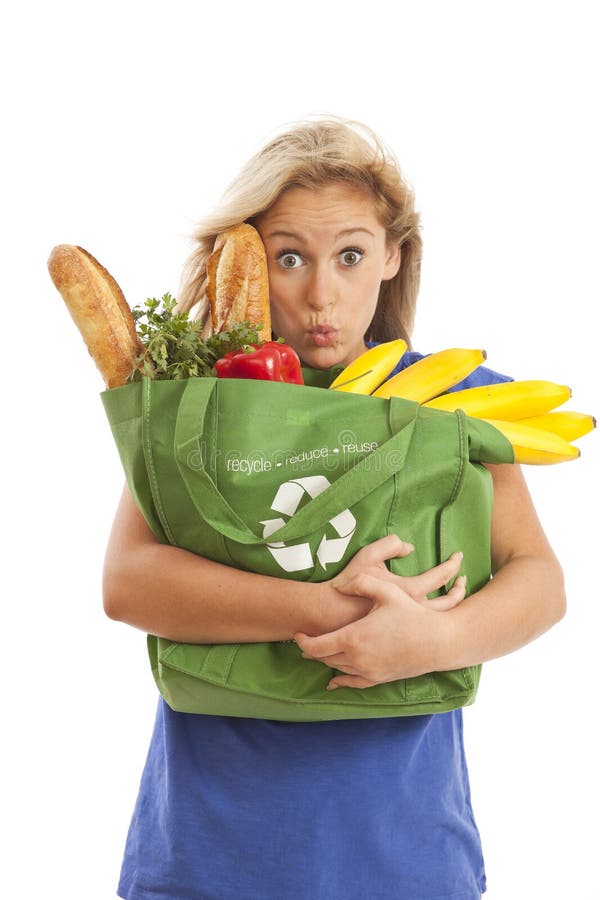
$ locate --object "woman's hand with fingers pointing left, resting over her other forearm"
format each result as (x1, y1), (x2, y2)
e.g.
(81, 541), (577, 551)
(294, 573), (464, 690)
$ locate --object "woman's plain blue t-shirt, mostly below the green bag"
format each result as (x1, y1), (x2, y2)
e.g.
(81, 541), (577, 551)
(118, 353), (509, 900)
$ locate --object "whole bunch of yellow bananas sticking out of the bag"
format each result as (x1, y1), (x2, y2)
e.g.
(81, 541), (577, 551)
(331, 340), (596, 465)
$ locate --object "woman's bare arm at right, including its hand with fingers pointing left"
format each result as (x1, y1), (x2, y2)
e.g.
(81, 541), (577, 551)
(296, 465), (565, 687)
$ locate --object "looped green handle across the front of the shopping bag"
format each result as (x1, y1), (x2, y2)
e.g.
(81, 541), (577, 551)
(164, 378), (418, 545)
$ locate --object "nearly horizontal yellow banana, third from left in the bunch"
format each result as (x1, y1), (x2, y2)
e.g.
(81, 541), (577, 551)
(425, 381), (571, 421)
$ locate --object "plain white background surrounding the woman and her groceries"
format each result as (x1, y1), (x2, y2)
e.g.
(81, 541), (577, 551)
(0, 0), (600, 900)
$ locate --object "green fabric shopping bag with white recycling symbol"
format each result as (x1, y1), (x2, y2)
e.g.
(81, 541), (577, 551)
(102, 370), (514, 721)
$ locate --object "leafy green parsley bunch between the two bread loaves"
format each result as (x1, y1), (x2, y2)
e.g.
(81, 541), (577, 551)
(130, 294), (260, 381)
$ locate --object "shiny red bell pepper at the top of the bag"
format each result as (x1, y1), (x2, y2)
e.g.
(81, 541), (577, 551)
(215, 341), (304, 384)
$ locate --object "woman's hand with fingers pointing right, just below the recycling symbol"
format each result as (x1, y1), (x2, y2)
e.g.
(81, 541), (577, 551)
(321, 534), (466, 631)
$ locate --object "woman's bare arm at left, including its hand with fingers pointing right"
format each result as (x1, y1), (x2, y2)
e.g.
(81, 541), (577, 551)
(103, 487), (464, 644)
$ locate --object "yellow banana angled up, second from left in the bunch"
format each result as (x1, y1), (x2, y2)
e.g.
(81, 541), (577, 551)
(373, 348), (486, 403)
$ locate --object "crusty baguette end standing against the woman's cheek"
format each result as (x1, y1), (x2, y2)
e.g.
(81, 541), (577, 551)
(206, 223), (271, 341)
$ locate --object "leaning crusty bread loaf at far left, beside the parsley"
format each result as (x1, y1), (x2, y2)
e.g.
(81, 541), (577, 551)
(48, 244), (144, 388)
